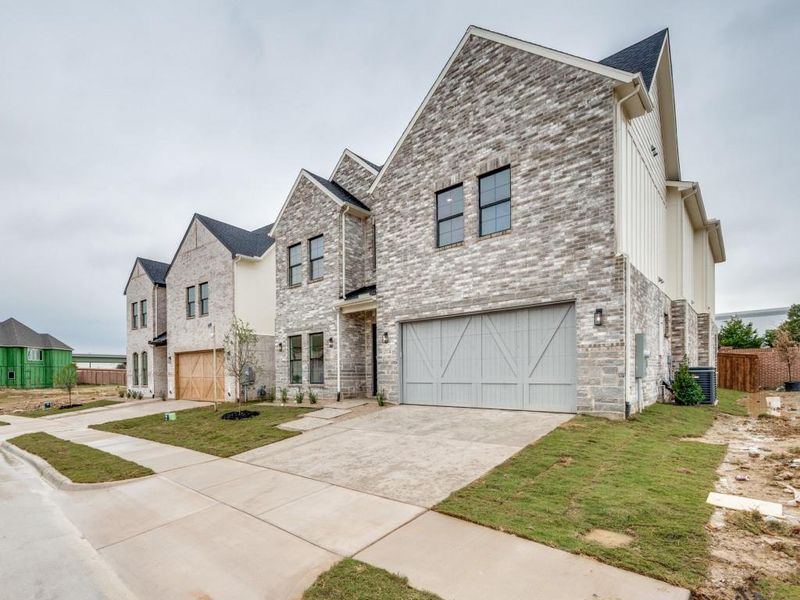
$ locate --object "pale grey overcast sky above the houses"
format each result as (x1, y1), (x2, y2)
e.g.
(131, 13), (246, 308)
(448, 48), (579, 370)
(0, 0), (800, 353)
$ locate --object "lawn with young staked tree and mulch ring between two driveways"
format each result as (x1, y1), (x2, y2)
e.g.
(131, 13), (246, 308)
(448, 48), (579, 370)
(92, 405), (312, 457)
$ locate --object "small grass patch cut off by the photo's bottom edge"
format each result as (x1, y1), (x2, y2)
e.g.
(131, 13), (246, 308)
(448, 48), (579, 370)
(303, 558), (441, 600)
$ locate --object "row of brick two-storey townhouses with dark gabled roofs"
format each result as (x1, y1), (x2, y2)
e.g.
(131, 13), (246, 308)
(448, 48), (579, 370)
(127, 27), (725, 417)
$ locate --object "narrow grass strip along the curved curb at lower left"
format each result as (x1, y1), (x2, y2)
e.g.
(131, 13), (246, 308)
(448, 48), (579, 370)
(8, 432), (153, 483)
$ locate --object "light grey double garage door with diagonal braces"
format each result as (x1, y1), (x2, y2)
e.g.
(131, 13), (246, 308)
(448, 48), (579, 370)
(402, 304), (577, 412)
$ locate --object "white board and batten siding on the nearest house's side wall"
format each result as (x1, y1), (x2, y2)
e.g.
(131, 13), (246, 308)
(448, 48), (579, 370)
(616, 78), (667, 285)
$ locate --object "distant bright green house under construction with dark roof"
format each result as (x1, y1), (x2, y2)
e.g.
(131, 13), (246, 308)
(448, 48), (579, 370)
(0, 319), (72, 389)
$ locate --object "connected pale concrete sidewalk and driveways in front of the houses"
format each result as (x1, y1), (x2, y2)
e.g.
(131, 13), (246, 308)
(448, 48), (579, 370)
(0, 402), (688, 600)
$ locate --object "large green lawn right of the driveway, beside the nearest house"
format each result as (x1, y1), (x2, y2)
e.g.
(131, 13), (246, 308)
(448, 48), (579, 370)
(435, 404), (725, 588)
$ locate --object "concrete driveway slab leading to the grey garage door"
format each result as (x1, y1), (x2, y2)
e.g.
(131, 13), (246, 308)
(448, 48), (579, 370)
(234, 405), (571, 508)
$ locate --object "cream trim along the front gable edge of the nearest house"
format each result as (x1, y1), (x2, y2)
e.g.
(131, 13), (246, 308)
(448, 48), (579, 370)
(368, 25), (653, 194)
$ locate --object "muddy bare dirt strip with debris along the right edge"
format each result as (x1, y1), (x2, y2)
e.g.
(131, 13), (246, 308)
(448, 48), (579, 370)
(694, 392), (800, 600)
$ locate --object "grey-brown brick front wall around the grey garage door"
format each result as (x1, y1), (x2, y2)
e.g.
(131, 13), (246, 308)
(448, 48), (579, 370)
(372, 38), (625, 415)
